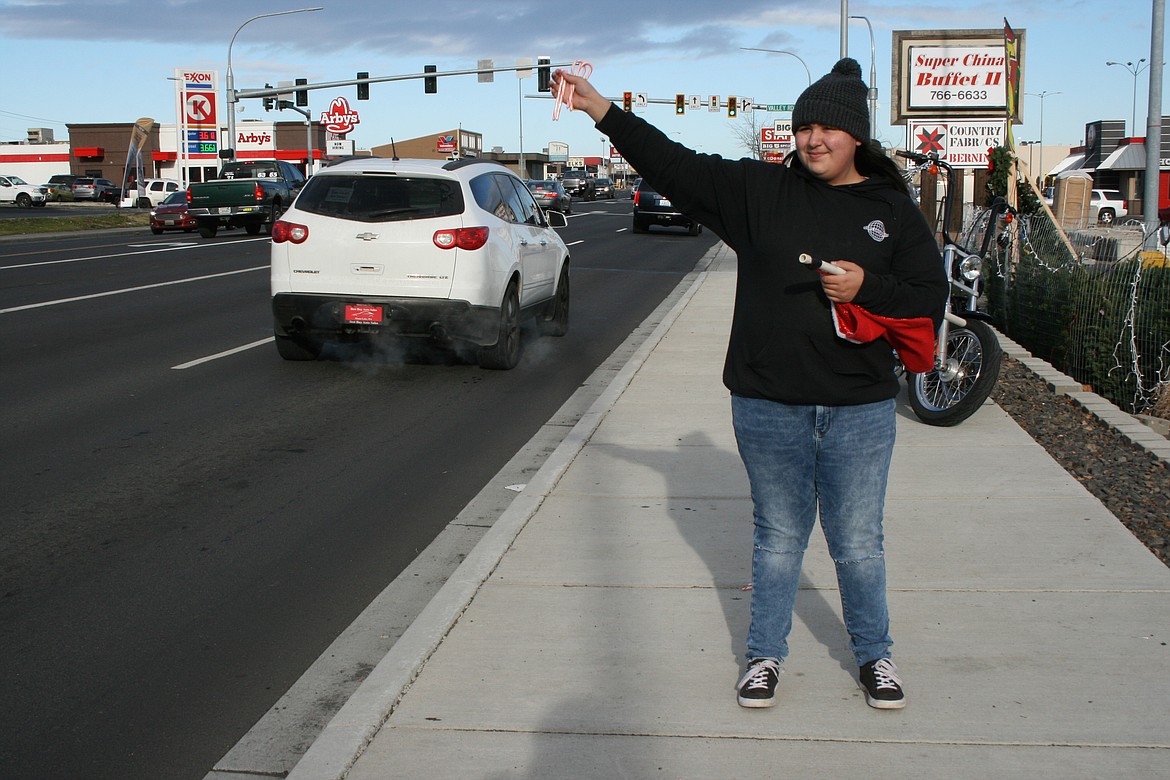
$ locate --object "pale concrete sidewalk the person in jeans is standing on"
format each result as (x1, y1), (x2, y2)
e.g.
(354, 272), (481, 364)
(289, 248), (1170, 780)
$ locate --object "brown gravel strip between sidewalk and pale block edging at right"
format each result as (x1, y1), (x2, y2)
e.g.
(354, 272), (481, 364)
(991, 354), (1170, 566)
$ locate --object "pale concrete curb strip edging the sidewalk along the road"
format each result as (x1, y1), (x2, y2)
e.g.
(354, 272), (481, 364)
(279, 242), (727, 780)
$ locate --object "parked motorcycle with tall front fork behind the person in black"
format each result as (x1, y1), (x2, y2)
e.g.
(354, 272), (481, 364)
(896, 151), (1014, 427)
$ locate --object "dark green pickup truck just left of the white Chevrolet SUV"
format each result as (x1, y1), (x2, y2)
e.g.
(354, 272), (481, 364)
(187, 160), (304, 239)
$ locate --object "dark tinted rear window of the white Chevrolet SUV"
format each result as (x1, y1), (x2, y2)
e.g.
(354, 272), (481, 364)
(296, 174), (463, 222)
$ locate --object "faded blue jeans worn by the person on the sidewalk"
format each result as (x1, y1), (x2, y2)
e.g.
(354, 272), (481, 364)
(731, 395), (895, 665)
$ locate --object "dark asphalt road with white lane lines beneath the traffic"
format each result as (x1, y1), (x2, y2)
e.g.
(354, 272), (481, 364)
(0, 201), (714, 780)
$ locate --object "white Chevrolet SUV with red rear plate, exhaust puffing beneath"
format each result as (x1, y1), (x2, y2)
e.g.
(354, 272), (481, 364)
(271, 158), (569, 368)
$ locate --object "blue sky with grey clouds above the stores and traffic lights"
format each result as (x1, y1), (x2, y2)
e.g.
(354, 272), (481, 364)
(0, 0), (1170, 157)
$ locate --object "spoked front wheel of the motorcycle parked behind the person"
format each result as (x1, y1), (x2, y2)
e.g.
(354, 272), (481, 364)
(906, 319), (1004, 427)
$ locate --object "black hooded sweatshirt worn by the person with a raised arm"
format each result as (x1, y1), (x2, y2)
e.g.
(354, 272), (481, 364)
(597, 106), (949, 406)
